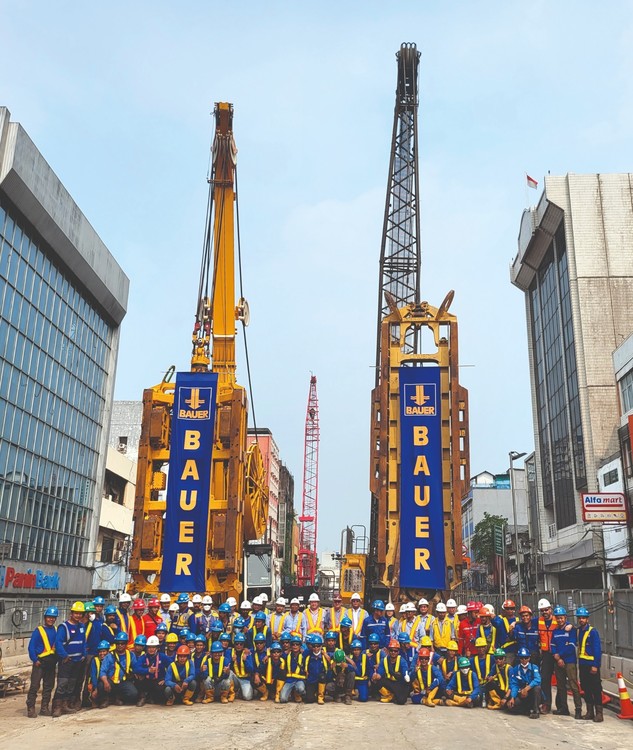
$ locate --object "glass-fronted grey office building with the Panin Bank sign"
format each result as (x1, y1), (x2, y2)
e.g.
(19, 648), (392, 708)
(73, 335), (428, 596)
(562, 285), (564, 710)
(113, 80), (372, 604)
(0, 108), (129, 604)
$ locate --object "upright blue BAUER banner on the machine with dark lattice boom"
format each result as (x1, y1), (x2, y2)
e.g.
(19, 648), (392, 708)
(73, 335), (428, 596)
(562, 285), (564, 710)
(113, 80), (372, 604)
(398, 367), (446, 589)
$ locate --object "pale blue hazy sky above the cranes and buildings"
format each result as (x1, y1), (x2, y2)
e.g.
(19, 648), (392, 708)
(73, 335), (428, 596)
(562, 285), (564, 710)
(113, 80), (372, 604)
(0, 0), (633, 549)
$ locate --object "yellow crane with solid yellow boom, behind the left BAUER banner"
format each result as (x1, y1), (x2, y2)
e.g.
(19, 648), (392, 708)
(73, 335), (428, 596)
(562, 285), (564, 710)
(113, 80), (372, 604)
(130, 102), (268, 596)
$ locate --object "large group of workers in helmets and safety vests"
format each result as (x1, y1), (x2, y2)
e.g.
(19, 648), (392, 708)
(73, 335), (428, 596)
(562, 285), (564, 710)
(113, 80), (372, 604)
(27, 593), (603, 722)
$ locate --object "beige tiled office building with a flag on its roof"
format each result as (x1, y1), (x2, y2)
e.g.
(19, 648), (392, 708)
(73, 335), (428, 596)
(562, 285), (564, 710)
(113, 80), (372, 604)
(510, 174), (633, 588)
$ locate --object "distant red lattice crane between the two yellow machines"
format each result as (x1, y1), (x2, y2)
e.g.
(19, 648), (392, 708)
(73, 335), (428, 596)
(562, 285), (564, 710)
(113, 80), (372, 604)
(297, 375), (319, 586)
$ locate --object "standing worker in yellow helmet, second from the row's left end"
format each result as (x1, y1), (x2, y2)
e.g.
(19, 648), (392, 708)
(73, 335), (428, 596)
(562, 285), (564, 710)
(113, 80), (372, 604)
(51, 602), (87, 718)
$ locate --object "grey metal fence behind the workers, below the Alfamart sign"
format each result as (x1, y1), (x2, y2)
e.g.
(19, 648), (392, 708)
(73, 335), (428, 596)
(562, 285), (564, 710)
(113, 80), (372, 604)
(453, 589), (633, 659)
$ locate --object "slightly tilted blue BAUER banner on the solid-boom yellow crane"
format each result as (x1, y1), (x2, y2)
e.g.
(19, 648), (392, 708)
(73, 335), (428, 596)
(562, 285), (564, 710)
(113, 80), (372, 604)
(160, 372), (218, 593)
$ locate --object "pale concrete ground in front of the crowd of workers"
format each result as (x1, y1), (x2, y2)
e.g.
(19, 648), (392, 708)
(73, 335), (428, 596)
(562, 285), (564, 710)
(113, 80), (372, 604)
(0, 695), (633, 750)
